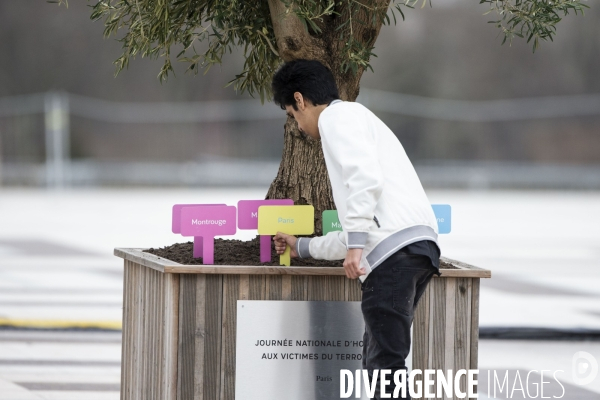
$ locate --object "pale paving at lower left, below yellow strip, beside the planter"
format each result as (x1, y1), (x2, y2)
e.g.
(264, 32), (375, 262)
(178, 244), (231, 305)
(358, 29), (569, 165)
(0, 330), (121, 400)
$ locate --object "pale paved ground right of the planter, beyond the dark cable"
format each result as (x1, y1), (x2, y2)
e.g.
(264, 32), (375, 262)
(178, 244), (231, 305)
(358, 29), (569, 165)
(430, 191), (600, 329)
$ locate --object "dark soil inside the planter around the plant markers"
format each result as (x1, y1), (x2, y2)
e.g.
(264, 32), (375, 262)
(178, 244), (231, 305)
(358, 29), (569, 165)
(145, 236), (455, 269)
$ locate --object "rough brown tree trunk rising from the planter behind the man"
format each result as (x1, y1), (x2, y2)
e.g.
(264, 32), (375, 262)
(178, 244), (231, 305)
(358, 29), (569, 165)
(266, 0), (389, 235)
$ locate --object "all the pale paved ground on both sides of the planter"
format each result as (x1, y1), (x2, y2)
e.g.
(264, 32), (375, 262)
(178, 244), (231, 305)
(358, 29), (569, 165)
(0, 188), (600, 400)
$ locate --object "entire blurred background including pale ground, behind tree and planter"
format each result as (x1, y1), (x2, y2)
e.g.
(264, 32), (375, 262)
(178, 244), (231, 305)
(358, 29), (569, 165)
(0, 0), (600, 400)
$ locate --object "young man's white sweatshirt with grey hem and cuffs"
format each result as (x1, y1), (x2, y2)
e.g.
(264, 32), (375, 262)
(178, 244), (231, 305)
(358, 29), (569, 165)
(296, 100), (438, 280)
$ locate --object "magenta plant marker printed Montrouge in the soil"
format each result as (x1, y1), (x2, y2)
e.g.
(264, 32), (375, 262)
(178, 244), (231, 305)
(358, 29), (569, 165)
(181, 205), (237, 265)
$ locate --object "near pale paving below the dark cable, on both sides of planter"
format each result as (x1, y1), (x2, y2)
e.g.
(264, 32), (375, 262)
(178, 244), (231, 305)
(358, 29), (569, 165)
(0, 330), (600, 400)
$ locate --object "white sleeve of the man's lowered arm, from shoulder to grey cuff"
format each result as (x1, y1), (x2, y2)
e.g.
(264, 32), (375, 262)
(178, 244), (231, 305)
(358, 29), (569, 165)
(319, 104), (384, 249)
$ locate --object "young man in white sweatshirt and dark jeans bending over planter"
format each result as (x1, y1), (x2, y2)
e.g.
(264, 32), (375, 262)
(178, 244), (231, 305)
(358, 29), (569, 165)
(273, 60), (440, 399)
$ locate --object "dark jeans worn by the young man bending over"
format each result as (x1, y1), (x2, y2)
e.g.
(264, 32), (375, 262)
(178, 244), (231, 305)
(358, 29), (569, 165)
(361, 250), (437, 399)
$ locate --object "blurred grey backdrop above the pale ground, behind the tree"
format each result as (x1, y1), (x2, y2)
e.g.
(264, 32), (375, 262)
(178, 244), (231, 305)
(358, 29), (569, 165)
(0, 0), (600, 189)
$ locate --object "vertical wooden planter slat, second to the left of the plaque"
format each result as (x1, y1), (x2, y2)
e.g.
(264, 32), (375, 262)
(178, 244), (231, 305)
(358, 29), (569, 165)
(204, 275), (223, 400)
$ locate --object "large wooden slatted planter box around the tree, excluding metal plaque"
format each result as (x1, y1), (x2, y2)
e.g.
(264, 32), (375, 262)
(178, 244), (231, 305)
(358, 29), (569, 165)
(114, 248), (491, 400)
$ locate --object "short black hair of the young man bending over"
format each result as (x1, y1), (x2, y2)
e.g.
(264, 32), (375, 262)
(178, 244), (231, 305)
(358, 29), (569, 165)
(271, 60), (340, 110)
